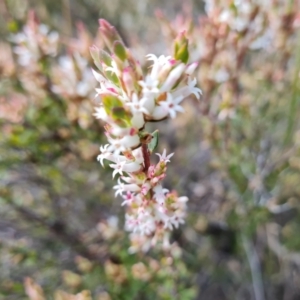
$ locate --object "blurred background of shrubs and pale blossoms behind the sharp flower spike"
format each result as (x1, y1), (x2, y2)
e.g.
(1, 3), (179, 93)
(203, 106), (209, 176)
(0, 0), (300, 300)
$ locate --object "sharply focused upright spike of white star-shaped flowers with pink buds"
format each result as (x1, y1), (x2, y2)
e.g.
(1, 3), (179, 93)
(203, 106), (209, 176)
(91, 20), (201, 250)
